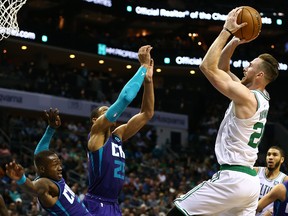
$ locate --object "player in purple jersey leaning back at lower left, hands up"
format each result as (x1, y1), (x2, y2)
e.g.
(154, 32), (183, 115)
(6, 108), (91, 216)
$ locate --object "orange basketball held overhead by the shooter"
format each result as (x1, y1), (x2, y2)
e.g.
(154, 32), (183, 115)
(234, 6), (262, 40)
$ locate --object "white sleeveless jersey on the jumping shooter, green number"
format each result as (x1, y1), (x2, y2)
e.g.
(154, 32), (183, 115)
(215, 90), (270, 168)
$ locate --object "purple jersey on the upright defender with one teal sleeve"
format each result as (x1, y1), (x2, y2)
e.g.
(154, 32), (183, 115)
(84, 135), (125, 202)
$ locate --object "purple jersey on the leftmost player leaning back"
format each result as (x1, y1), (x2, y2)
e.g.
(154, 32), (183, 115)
(40, 178), (91, 216)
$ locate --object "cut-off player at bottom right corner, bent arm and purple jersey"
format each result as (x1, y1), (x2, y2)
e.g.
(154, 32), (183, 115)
(257, 181), (288, 216)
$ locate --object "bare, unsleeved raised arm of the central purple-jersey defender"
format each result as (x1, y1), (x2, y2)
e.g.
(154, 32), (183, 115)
(114, 59), (155, 141)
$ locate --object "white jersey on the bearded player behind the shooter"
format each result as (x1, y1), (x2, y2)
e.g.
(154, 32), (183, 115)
(256, 167), (286, 216)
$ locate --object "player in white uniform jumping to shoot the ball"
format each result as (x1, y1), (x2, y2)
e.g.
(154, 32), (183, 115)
(168, 8), (278, 216)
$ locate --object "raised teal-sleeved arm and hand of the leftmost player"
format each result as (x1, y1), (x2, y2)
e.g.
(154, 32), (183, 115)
(34, 108), (61, 155)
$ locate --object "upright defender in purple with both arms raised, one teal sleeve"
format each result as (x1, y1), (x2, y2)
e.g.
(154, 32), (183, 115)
(84, 45), (154, 216)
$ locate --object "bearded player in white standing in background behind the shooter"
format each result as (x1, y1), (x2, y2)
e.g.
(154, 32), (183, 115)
(254, 146), (288, 216)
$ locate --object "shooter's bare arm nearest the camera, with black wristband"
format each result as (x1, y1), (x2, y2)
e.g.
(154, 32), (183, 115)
(200, 8), (257, 112)
